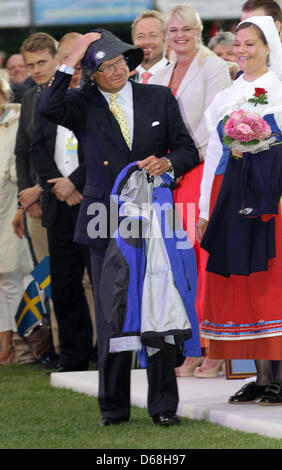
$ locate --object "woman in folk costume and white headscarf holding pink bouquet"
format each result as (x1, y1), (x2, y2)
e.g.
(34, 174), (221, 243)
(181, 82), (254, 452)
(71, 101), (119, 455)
(197, 16), (282, 405)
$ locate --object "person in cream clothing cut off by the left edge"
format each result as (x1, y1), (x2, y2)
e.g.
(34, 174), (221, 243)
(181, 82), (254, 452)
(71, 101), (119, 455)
(0, 76), (32, 364)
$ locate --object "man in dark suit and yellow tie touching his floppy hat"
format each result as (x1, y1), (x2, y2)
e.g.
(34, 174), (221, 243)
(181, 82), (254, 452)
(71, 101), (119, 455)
(39, 30), (199, 426)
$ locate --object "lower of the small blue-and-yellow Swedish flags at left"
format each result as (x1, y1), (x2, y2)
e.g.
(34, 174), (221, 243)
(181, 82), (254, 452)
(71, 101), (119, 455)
(15, 281), (44, 336)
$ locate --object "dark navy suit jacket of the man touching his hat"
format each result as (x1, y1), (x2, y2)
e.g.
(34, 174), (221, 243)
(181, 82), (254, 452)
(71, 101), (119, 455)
(38, 71), (199, 246)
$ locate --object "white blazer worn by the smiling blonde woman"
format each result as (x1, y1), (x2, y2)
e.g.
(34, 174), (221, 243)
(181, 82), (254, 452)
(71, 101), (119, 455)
(148, 52), (231, 160)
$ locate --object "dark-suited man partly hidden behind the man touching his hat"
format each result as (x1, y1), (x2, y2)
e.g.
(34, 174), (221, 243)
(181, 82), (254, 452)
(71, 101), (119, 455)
(30, 32), (93, 372)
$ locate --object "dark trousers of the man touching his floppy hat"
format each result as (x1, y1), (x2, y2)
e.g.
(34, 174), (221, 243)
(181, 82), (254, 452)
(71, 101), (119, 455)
(90, 242), (178, 418)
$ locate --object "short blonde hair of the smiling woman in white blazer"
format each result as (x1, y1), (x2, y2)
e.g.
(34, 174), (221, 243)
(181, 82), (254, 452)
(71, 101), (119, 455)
(164, 5), (216, 64)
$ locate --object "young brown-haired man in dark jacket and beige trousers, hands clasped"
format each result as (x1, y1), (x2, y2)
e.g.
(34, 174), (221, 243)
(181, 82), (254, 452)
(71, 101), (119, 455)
(12, 32), (58, 367)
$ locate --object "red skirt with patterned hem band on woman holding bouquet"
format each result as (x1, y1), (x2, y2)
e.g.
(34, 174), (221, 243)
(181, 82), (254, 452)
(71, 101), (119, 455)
(202, 175), (282, 360)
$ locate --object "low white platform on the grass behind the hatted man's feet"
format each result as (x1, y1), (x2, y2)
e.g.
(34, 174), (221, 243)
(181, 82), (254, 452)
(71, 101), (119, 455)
(51, 369), (282, 439)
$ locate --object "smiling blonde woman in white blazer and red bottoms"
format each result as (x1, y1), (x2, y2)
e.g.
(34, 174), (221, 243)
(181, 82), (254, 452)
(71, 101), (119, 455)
(149, 5), (231, 377)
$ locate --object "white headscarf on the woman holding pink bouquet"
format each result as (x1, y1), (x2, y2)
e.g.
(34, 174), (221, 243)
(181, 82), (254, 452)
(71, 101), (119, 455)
(238, 16), (282, 80)
